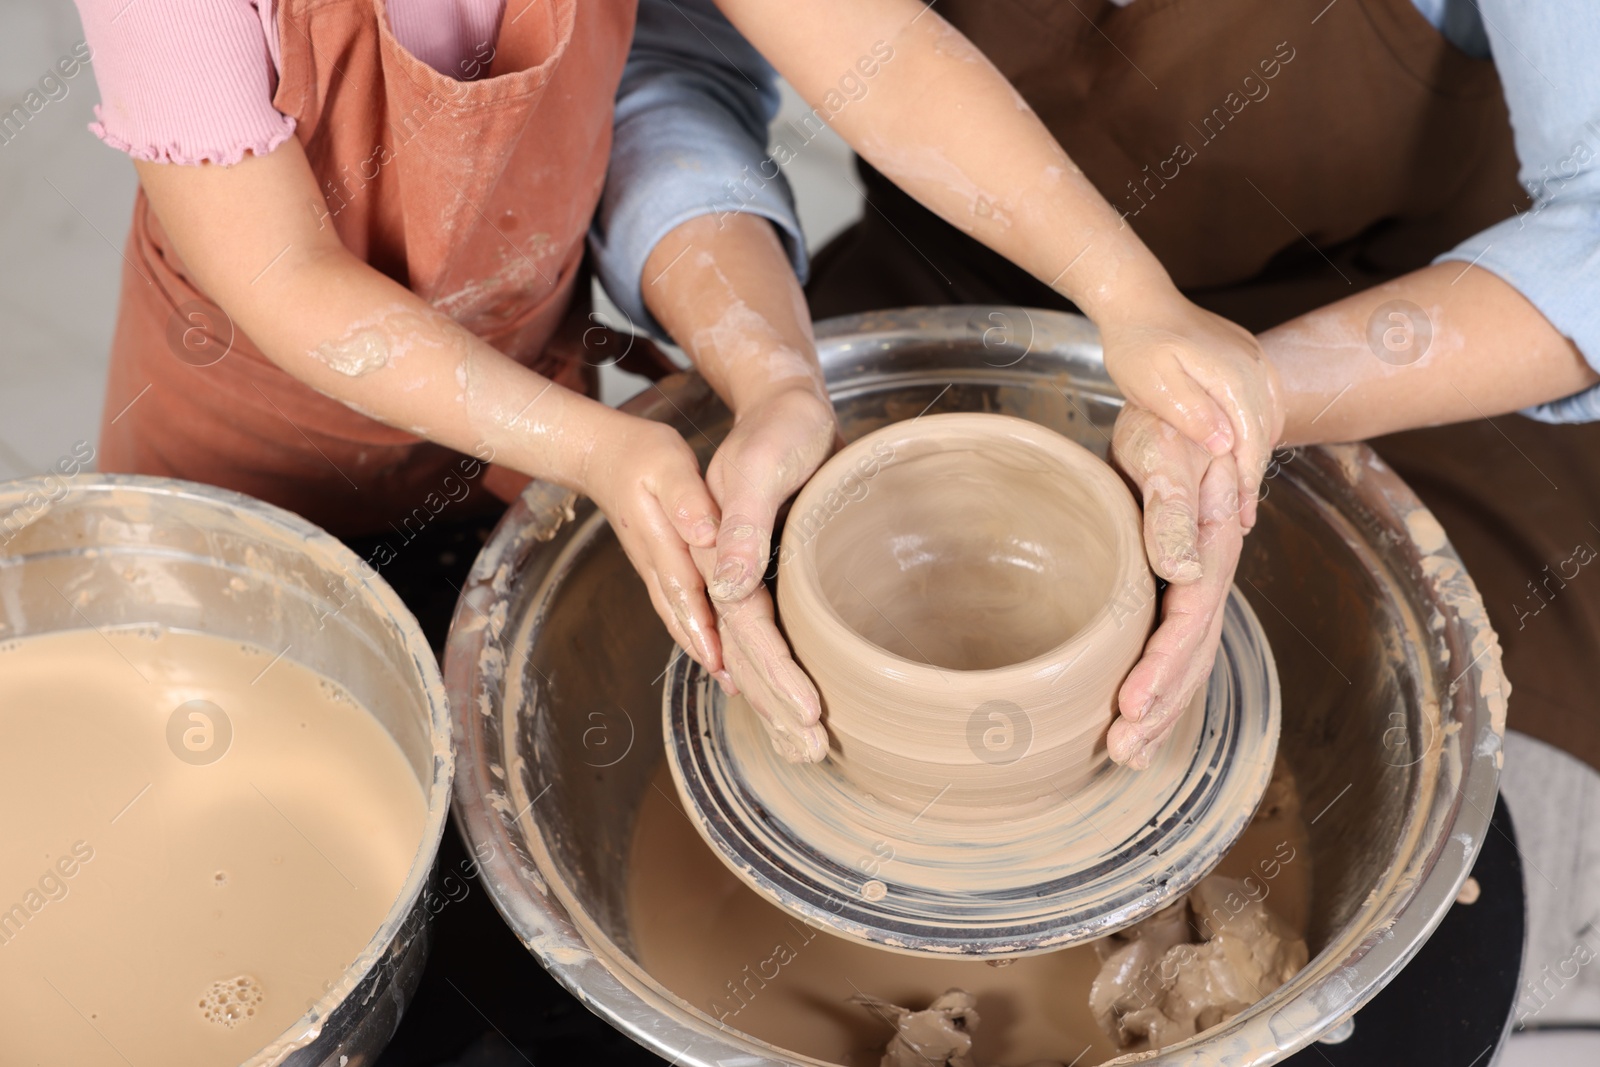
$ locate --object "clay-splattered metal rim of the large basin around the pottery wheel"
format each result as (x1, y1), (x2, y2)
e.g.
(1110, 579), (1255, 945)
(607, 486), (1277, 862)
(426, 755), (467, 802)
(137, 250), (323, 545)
(445, 307), (1507, 1067)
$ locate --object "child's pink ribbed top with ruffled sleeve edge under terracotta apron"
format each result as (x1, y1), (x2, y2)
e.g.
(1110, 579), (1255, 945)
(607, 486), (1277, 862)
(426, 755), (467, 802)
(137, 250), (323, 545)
(77, 0), (506, 163)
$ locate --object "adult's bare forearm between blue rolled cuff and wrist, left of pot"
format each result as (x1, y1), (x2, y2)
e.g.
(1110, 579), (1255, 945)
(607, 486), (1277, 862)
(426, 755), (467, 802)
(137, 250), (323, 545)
(643, 214), (826, 413)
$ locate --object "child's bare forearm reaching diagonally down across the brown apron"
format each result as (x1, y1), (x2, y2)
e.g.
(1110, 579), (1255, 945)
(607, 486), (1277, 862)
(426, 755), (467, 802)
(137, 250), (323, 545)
(718, 0), (1176, 322)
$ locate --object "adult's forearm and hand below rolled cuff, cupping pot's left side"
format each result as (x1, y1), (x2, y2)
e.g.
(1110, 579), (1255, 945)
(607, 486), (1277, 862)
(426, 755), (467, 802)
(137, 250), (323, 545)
(643, 213), (838, 761)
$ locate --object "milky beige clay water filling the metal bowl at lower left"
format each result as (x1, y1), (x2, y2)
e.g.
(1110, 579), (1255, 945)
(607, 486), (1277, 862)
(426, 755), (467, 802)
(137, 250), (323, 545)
(0, 629), (427, 1067)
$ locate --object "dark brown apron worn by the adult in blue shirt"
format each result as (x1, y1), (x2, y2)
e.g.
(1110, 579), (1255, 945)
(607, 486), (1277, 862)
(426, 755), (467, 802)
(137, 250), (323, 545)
(808, 0), (1600, 768)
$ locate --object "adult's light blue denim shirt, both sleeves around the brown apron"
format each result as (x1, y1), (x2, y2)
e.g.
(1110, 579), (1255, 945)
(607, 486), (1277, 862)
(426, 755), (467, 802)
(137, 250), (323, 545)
(590, 0), (1600, 422)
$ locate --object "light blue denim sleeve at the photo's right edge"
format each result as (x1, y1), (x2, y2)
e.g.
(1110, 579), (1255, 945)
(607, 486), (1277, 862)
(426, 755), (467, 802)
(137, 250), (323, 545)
(1437, 0), (1600, 422)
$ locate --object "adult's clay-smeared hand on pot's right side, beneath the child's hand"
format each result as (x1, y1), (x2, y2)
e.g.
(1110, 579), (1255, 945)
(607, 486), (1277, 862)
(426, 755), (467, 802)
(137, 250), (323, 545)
(1106, 403), (1243, 769)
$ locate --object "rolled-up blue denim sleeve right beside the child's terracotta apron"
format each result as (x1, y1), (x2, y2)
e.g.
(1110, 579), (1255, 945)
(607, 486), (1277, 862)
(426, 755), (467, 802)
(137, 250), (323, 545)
(589, 0), (806, 338)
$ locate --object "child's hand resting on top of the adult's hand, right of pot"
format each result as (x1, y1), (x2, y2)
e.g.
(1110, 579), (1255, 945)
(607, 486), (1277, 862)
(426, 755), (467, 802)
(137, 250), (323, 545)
(1098, 291), (1283, 534)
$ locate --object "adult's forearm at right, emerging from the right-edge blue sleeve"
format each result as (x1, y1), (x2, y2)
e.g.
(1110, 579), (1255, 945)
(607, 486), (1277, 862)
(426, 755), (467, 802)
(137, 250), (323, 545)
(1261, 262), (1600, 445)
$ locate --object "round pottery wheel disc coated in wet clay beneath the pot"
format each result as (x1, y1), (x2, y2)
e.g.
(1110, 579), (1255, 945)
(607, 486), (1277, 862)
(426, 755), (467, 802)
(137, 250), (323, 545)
(662, 589), (1280, 957)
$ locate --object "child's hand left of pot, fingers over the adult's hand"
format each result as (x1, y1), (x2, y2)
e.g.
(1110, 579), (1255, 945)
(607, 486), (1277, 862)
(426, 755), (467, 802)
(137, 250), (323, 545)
(579, 408), (723, 675)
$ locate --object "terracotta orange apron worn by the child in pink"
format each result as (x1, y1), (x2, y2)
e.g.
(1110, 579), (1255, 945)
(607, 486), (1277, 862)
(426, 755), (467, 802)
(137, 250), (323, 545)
(99, 0), (635, 534)
